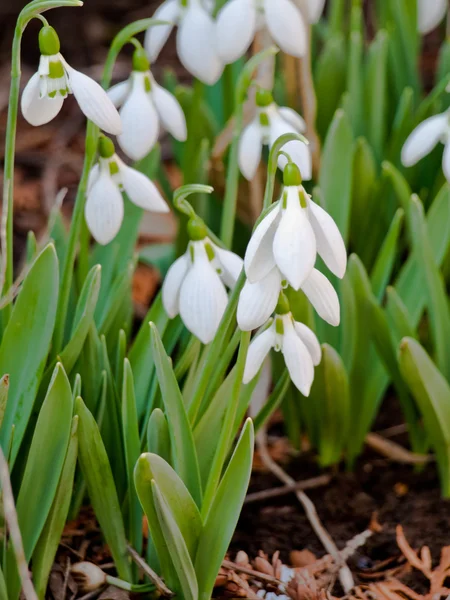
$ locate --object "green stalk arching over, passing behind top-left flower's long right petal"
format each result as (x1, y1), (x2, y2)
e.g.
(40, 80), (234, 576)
(52, 19), (166, 358)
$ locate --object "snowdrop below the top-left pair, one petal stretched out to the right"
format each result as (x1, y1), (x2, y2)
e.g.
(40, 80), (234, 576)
(84, 136), (169, 245)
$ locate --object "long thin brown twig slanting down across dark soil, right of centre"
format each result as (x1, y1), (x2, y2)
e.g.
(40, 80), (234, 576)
(256, 428), (354, 593)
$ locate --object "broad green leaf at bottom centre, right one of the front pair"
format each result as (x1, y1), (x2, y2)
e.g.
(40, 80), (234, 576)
(194, 419), (254, 600)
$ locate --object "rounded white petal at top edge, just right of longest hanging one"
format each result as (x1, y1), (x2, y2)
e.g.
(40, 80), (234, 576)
(216, 0), (256, 64)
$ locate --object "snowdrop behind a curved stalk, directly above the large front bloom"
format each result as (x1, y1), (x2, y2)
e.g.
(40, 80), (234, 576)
(238, 89), (312, 181)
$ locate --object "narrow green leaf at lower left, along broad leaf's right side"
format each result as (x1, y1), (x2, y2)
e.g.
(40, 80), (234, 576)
(33, 416), (78, 600)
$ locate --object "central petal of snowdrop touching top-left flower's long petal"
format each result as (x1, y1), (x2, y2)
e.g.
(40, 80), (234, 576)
(117, 73), (159, 160)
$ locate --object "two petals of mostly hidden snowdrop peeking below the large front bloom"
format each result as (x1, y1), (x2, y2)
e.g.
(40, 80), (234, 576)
(237, 267), (341, 331)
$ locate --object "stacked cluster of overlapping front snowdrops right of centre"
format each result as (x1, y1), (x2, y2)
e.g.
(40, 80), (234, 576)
(237, 163), (347, 396)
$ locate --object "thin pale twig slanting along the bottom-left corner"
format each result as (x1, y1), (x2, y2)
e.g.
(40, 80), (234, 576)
(0, 448), (38, 600)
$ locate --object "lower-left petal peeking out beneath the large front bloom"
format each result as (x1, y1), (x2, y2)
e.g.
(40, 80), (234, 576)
(237, 267), (281, 331)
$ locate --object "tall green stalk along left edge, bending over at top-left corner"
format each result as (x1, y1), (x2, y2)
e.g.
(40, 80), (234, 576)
(0, 0), (82, 326)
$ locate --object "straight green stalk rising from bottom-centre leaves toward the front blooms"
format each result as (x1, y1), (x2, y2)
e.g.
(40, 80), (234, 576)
(201, 332), (251, 522)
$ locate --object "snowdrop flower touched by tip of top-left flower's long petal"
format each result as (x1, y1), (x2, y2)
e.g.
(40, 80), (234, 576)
(108, 48), (187, 160)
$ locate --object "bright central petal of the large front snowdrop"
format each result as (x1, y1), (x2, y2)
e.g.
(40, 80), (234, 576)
(273, 187), (316, 290)
